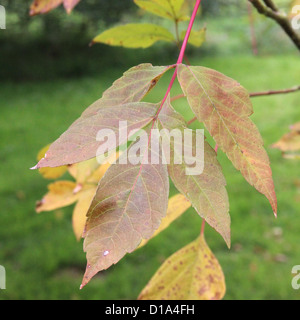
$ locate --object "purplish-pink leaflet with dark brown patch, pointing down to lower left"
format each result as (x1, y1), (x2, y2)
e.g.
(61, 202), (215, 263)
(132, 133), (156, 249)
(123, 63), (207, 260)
(83, 125), (169, 285)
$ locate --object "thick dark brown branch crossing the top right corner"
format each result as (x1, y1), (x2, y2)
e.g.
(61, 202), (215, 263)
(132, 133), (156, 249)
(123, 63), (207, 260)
(248, 0), (300, 51)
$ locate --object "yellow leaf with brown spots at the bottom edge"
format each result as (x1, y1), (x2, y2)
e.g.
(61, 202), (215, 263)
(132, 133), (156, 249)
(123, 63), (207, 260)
(139, 236), (226, 300)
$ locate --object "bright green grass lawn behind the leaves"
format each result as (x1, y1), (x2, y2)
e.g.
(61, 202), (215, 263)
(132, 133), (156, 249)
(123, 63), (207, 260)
(0, 55), (300, 299)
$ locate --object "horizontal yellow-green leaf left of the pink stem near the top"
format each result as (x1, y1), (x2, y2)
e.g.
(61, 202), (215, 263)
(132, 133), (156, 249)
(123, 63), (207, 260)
(92, 23), (174, 48)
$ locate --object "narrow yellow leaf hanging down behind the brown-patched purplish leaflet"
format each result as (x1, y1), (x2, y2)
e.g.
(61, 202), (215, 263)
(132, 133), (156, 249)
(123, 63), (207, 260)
(72, 186), (97, 241)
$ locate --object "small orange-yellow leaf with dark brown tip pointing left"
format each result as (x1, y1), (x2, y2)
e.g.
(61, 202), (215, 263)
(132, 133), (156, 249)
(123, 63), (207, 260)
(36, 181), (80, 212)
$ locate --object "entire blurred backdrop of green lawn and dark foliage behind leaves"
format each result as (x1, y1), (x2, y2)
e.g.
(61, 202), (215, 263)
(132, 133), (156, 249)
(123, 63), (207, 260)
(0, 0), (300, 300)
